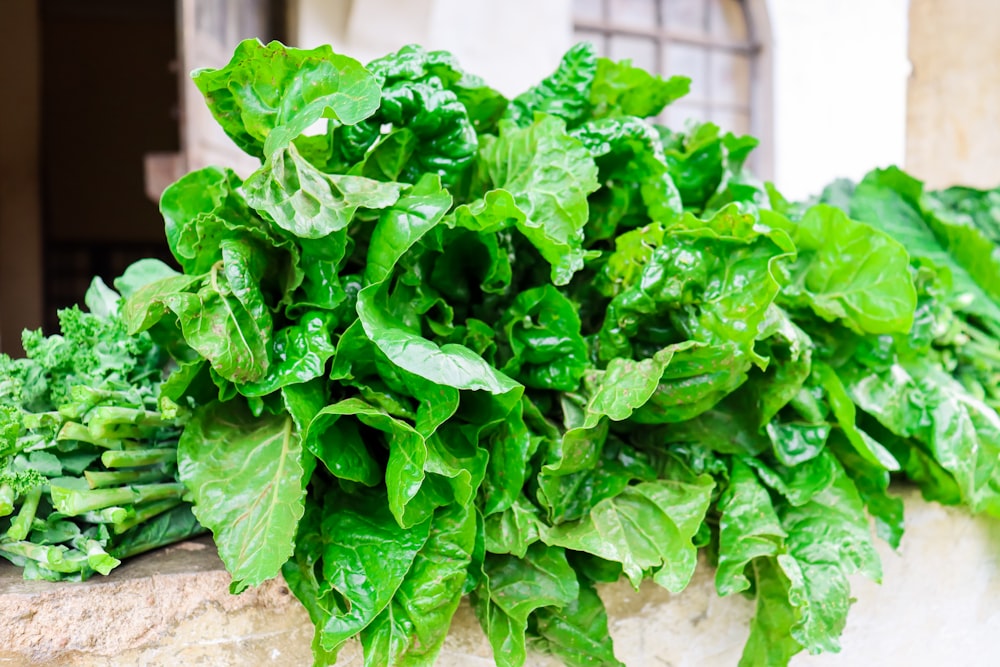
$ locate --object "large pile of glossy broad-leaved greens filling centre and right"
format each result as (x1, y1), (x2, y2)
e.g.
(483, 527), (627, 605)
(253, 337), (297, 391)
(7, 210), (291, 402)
(5, 41), (1000, 665)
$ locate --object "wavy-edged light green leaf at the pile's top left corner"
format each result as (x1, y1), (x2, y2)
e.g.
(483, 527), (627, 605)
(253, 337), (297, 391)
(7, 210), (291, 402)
(192, 39), (379, 158)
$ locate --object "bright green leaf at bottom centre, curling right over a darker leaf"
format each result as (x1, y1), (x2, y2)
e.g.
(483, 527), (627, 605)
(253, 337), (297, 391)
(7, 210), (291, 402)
(472, 543), (580, 667)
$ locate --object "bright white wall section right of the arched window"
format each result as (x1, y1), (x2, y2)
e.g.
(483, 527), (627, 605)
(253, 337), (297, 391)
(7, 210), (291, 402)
(767, 0), (910, 198)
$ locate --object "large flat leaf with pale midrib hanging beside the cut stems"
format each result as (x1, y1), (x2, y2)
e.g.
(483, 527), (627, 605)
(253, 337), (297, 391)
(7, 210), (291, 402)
(177, 401), (304, 593)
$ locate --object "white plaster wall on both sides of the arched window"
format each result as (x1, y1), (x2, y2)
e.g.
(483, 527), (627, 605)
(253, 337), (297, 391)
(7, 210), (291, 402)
(292, 0), (910, 198)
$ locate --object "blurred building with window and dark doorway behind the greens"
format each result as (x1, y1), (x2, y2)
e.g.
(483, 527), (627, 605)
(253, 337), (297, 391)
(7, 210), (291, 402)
(0, 0), (988, 355)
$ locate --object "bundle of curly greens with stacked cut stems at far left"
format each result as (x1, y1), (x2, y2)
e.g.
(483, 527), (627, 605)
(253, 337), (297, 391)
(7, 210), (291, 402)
(0, 276), (204, 581)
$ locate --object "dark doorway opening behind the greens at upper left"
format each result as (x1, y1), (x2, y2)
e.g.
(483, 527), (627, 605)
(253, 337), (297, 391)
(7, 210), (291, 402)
(40, 0), (180, 333)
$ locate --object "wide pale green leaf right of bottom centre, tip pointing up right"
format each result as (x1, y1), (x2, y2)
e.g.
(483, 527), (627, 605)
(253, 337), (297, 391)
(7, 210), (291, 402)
(544, 475), (715, 593)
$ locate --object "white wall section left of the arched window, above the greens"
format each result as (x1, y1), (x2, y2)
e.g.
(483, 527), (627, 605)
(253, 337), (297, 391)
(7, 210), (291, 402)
(291, 0), (572, 96)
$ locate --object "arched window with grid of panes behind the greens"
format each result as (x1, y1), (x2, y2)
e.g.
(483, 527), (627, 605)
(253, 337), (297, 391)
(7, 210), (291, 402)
(573, 0), (771, 176)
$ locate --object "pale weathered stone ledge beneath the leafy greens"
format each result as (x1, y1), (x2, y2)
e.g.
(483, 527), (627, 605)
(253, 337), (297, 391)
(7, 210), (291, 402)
(0, 489), (1000, 667)
